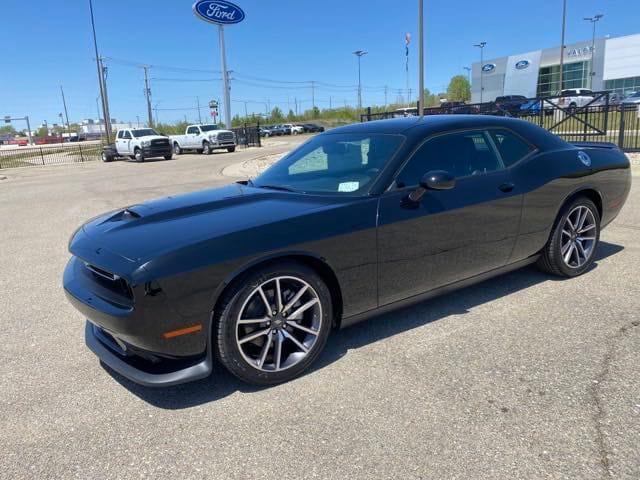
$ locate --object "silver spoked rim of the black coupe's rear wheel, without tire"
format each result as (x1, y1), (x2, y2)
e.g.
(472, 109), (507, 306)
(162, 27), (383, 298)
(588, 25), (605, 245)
(560, 205), (596, 268)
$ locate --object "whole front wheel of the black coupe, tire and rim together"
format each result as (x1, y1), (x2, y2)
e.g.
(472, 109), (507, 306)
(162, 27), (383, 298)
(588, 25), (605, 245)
(213, 262), (333, 385)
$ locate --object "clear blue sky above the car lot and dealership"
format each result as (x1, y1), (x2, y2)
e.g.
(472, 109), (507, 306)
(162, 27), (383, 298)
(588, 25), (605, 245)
(0, 0), (640, 125)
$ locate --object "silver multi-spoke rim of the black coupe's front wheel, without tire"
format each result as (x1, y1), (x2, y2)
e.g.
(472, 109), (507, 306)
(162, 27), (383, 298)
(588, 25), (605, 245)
(236, 276), (322, 372)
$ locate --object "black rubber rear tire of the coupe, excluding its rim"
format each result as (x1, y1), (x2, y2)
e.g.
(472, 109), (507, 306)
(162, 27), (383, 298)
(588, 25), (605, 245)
(537, 197), (600, 277)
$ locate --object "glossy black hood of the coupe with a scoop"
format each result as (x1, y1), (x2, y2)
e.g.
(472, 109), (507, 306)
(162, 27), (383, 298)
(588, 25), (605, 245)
(75, 184), (336, 265)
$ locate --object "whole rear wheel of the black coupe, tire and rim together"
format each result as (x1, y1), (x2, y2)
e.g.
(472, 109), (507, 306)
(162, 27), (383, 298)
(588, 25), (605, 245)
(538, 197), (600, 277)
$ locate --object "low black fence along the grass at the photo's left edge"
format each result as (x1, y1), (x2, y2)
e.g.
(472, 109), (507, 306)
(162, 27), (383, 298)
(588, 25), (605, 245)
(0, 142), (102, 169)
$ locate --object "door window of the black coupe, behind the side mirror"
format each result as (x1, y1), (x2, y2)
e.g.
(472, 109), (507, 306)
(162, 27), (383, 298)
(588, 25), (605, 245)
(396, 131), (503, 187)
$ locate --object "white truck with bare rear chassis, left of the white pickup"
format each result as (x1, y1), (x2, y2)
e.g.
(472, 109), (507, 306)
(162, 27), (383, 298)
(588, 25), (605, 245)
(115, 128), (173, 162)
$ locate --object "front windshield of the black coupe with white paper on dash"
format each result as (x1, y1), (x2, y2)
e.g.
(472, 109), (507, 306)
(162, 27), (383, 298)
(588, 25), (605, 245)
(253, 133), (404, 194)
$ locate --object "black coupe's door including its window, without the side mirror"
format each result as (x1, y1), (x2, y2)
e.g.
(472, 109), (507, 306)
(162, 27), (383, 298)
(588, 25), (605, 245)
(378, 130), (522, 305)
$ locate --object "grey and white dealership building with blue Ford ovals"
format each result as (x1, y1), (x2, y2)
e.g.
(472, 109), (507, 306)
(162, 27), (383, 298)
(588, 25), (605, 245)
(471, 34), (640, 103)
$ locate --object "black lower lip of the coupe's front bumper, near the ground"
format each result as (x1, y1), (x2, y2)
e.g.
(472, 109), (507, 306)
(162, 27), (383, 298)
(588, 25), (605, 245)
(84, 320), (212, 387)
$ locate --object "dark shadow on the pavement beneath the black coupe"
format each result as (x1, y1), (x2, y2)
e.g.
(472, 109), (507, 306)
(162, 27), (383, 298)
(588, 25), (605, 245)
(103, 242), (624, 410)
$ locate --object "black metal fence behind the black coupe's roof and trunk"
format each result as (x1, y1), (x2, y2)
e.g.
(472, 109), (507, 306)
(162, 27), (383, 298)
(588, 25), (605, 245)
(360, 92), (640, 152)
